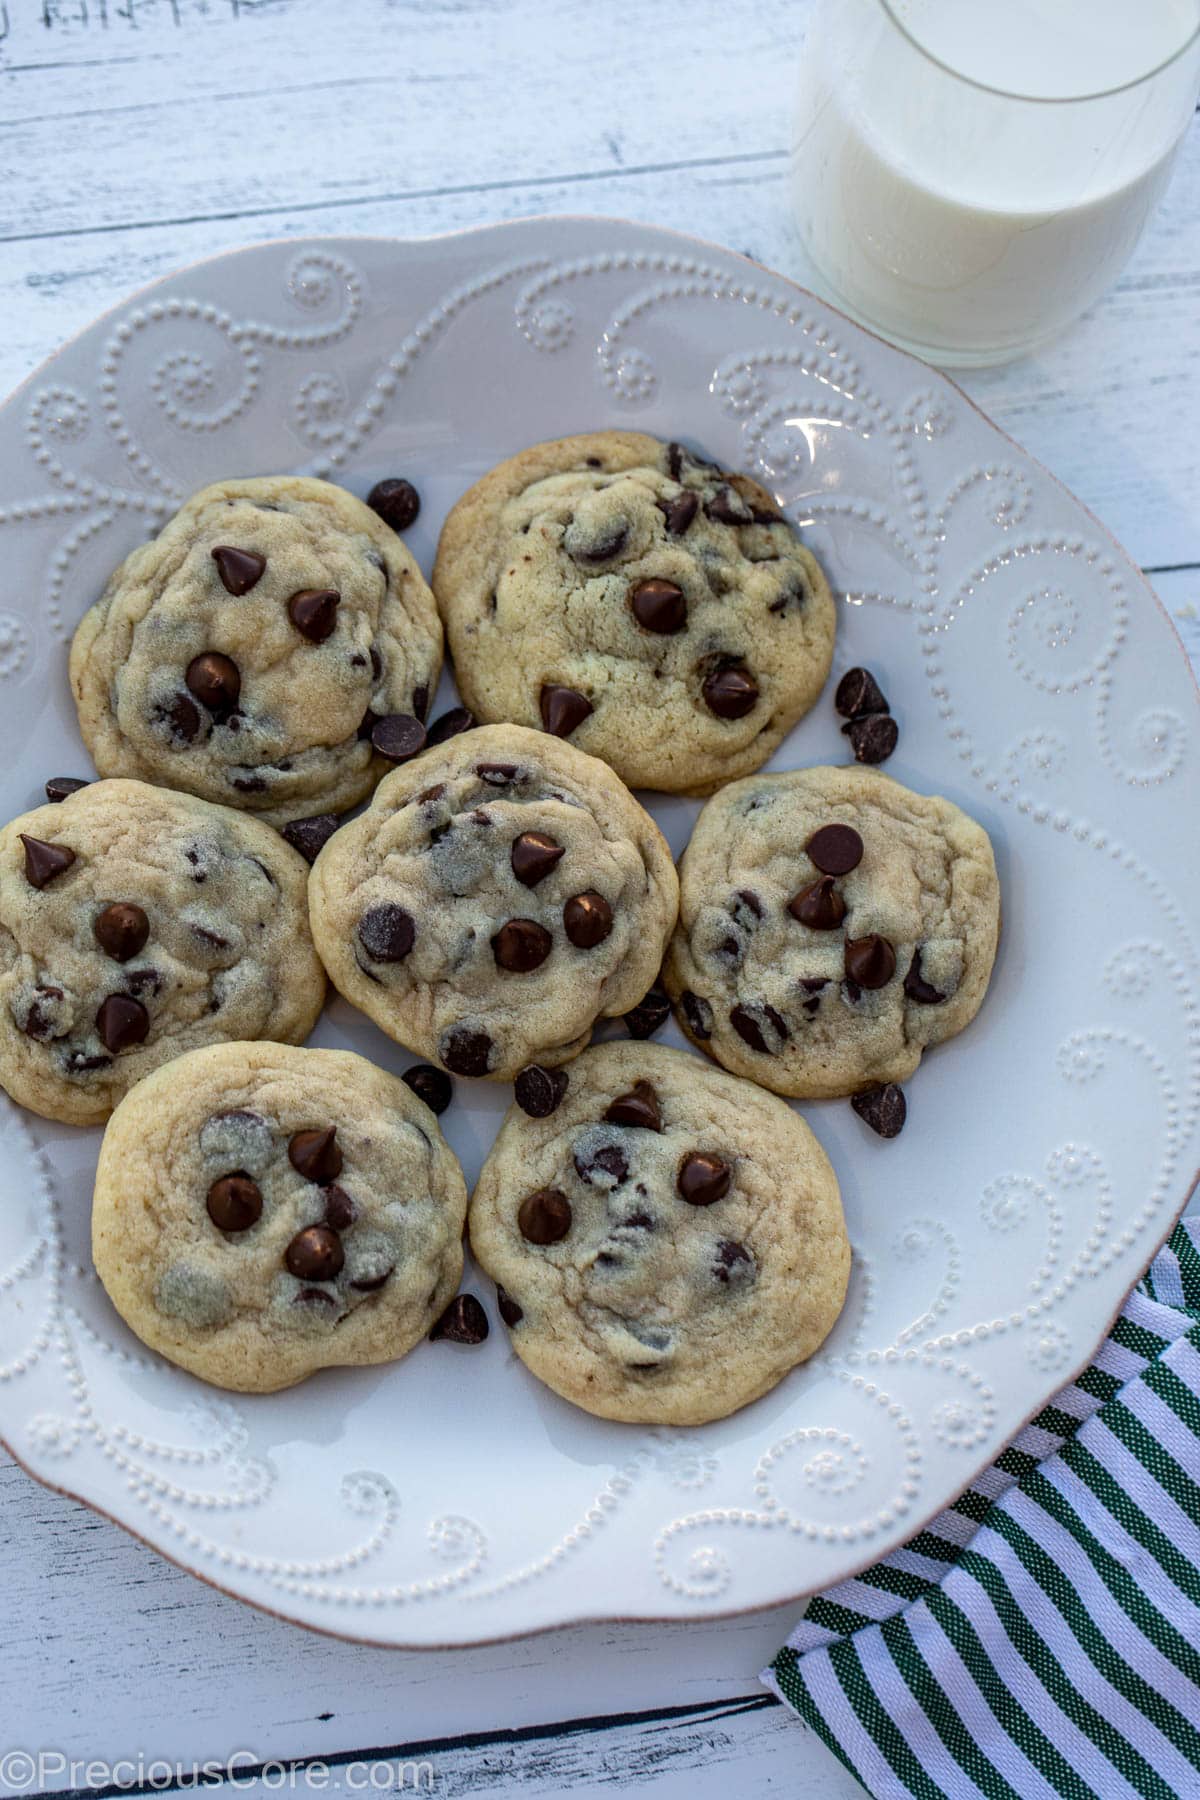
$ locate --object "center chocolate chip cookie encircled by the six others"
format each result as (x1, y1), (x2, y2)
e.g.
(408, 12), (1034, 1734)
(309, 725), (678, 1080)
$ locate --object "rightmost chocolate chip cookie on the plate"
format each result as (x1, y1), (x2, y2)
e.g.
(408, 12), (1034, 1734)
(664, 769), (1000, 1094)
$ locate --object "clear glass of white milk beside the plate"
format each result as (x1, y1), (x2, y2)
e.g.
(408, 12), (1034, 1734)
(792, 0), (1200, 365)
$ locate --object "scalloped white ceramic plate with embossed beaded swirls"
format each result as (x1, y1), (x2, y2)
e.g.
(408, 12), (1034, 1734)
(0, 220), (1200, 1645)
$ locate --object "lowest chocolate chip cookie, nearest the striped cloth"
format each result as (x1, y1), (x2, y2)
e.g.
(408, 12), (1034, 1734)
(470, 1044), (849, 1426)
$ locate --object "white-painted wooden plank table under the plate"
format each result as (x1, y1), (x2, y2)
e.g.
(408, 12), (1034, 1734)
(0, 0), (1200, 1800)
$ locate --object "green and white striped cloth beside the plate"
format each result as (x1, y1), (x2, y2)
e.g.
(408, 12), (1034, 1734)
(763, 1220), (1200, 1800)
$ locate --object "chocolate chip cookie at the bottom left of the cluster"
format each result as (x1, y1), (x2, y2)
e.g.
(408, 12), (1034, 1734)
(92, 1044), (466, 1393)
